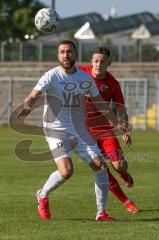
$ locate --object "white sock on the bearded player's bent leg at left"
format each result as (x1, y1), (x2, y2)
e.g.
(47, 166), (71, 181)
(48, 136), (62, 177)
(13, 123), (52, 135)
(40, 170), (66, 198)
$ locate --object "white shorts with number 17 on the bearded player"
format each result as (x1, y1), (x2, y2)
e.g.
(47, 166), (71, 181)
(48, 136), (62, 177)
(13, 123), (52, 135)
(46, 131), (102, 164)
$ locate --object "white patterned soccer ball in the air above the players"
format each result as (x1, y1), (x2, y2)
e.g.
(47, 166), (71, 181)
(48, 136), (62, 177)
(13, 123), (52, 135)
(35, 8), (60, 32)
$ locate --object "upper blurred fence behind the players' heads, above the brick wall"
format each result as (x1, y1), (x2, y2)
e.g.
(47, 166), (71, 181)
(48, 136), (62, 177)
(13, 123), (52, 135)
(0, 40), (159, 62)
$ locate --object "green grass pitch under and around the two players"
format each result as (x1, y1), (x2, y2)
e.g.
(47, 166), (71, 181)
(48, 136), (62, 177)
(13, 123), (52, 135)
(0, 128), (159, 240)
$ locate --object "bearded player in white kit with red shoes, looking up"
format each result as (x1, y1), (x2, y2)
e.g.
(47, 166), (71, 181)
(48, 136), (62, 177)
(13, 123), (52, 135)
(18, 40), (129, 221)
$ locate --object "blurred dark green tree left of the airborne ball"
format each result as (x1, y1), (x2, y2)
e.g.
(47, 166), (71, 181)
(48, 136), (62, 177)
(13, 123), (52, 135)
(0, 0), (46, 41)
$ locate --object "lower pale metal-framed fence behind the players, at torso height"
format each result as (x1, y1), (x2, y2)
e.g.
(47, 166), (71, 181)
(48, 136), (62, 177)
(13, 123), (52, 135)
(0, 75), (159, 130)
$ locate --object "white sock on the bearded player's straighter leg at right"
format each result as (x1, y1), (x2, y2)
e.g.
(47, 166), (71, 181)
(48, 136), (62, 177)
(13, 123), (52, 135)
(95, 170), (109, 213)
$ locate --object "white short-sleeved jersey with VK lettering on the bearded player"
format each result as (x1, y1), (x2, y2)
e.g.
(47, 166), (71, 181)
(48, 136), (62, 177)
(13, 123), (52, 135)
(34, 66), (99, 136)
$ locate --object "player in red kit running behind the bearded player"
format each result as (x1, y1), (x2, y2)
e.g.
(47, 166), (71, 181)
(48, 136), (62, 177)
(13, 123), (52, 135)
(80, 47), (138, 213)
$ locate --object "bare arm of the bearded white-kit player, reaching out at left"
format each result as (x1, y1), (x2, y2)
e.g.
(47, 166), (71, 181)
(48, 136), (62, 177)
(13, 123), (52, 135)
(17, 89), (42, 117)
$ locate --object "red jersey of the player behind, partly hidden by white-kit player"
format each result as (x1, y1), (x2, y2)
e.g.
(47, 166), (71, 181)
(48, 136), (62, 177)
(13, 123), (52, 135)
(80, 66), (124, 140)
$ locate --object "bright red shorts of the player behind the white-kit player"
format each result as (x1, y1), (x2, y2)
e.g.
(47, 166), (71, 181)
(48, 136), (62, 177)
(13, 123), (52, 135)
(97, 136), (124, 162)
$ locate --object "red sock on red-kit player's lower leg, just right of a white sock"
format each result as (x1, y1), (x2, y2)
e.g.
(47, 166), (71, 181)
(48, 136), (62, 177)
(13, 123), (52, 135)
(107, 169), (128, 203)
